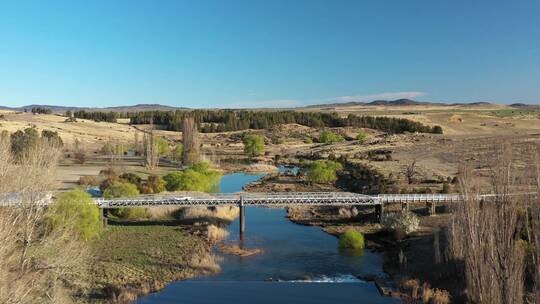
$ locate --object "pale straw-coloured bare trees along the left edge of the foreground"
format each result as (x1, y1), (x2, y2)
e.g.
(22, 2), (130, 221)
(0, 140), (88, 304)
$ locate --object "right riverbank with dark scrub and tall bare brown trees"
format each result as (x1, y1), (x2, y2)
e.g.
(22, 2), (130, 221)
(282, 145), (540, 303)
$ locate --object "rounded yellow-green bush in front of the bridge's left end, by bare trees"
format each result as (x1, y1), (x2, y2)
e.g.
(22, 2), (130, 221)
(46, 190), (102, 240)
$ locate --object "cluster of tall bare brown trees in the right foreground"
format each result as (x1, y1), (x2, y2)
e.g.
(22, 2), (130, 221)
(449, 149), (525, 304)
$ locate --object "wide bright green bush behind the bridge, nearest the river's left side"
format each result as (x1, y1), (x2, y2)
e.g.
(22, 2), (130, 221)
(163, 163), (221, 192)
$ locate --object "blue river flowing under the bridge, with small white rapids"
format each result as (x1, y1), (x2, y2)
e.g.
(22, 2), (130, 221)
(137, 168), (397, 304)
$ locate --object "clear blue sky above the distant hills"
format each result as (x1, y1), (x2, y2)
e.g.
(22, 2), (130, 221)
(0, 0), (540, 108)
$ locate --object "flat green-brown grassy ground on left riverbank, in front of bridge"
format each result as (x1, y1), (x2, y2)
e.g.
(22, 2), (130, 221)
(91, 222), (215, 302)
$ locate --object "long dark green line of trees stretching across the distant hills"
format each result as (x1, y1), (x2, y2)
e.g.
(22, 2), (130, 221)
(74, 110), (443, 134)
